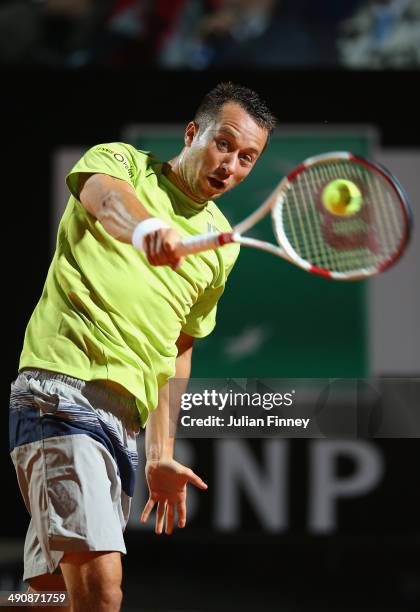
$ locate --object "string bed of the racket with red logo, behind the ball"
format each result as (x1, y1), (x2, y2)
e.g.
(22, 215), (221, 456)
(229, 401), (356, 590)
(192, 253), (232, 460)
(273, 160), (405, 272)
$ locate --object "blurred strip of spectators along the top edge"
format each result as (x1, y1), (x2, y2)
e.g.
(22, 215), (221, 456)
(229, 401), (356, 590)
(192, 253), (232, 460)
(0, 0), (420, 70)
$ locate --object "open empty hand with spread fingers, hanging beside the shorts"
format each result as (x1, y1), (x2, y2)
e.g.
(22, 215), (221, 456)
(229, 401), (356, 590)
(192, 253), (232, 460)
(140, 459), (207, 535)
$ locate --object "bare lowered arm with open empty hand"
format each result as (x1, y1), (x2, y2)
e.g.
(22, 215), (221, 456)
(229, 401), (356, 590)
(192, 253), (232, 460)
(141, 332), (207, 534)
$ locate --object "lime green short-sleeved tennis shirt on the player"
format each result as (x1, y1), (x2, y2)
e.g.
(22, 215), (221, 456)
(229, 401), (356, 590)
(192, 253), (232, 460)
(19, 143), (239, 425)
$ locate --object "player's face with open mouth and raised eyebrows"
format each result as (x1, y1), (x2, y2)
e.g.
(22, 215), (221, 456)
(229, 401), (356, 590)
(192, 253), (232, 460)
(180, 102), (268, 201)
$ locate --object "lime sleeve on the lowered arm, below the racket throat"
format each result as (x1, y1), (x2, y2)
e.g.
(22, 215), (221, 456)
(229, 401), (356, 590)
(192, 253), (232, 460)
(182, 245), (239, 338)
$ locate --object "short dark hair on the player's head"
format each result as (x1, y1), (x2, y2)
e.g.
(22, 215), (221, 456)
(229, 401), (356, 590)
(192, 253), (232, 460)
(194, 81), (276, 136)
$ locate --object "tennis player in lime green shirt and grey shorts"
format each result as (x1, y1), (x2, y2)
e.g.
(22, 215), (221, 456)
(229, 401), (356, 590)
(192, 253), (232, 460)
(10, 83), (275, 612)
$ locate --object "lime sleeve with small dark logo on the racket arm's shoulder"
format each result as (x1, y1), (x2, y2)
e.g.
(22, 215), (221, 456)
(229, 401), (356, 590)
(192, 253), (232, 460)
(66, 142), (140, 200)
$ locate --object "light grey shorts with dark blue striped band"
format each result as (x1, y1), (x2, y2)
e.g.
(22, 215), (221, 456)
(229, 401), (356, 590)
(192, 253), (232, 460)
(9, 369), (140, 580)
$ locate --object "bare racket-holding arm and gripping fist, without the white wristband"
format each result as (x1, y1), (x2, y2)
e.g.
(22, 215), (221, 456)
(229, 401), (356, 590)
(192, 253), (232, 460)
(78, 173), (183, 269)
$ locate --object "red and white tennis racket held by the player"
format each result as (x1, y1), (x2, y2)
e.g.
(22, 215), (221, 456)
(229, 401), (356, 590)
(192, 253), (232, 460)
(176, 151), (412, 280)
